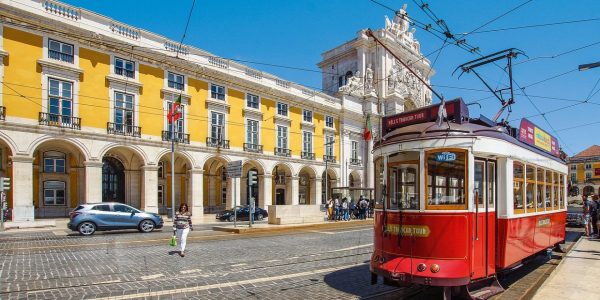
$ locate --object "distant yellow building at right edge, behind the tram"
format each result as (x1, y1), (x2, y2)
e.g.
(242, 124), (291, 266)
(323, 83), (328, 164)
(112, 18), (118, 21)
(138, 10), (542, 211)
(567, 145), (600, 198)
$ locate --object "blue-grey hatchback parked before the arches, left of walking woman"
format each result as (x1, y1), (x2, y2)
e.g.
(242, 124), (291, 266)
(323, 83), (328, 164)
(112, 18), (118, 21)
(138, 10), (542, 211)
(67, 202), (164, 235)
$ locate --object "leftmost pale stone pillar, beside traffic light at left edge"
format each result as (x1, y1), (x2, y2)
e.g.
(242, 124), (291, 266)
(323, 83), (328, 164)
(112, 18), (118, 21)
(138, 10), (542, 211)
(10, 156), (34, 222)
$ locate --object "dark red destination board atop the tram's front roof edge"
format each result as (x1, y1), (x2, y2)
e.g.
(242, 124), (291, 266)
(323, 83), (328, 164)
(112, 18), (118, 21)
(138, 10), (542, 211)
(381, 98), (469, 133)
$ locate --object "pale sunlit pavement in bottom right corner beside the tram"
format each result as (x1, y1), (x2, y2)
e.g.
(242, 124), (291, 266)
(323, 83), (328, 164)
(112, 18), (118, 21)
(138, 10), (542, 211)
(533, 237), (600, 300)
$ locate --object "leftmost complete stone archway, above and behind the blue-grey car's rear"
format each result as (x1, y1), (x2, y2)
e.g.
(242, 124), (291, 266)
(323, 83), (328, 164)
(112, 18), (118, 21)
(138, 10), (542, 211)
(29, 136), (89, 217)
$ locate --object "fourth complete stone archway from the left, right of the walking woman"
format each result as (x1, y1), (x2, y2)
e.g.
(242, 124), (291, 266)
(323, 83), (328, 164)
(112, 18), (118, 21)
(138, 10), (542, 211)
(202, 156), (231, 213)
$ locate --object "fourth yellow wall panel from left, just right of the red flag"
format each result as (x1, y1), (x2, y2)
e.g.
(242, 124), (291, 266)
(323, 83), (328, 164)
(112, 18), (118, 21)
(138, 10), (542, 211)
(187, 78), (208, 142)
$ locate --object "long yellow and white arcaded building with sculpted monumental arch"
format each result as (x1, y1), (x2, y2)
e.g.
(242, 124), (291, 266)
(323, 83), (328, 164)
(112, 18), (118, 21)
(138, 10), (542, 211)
(0, 0), (432, 221)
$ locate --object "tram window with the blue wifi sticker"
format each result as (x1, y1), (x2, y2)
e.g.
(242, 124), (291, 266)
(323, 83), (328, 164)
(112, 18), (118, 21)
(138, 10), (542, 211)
(425, 150), (467, 209)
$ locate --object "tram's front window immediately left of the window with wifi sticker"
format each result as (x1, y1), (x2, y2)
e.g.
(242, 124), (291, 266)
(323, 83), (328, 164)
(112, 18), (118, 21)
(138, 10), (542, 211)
(390, 162), (419, 209)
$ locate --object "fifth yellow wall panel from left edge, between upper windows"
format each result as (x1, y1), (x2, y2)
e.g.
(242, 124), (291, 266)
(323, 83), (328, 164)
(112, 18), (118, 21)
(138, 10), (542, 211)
(226, 88), (246, 148)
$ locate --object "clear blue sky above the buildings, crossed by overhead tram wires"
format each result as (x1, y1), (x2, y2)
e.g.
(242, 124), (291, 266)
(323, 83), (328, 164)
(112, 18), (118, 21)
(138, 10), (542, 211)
(66, 0), (600, 155)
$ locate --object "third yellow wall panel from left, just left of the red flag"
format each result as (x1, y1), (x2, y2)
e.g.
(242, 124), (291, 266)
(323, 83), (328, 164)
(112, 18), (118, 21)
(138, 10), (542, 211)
(139, 64), (163, 138)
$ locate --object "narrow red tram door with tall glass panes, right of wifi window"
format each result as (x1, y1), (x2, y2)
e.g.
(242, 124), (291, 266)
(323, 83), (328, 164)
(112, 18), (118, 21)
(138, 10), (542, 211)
(471, 159), (496, 278)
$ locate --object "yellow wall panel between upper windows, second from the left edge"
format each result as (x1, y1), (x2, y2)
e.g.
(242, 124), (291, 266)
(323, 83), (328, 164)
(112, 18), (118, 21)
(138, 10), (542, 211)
(79, 48), (112, 128)
